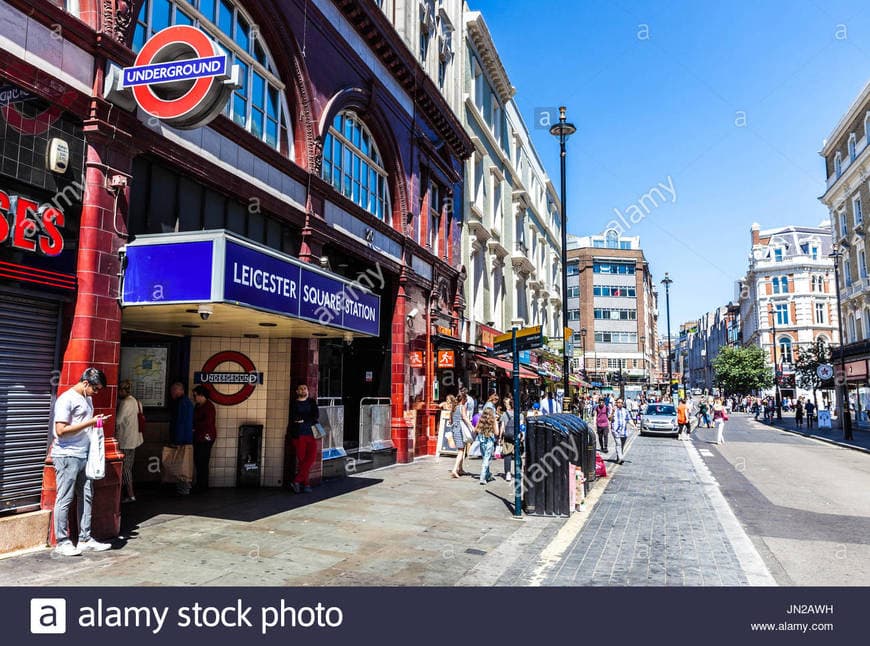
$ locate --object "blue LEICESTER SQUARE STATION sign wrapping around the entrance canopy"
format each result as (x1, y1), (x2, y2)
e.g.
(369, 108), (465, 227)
(122, 231), (380, 336)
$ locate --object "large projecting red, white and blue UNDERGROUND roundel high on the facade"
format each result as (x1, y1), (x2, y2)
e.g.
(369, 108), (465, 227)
(121, 25), (239, 129)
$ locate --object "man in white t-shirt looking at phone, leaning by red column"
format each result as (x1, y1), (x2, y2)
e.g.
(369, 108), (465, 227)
(51, 368), (111, 556)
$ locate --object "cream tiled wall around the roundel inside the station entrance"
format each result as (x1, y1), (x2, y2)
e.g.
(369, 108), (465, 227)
(189, 337), (290, 487)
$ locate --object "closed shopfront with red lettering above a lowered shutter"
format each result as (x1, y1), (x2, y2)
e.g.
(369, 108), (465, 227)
(0, 78), (84, 513)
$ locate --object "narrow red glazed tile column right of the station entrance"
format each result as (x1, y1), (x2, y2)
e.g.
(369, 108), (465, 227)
(390, 265), (414, 463)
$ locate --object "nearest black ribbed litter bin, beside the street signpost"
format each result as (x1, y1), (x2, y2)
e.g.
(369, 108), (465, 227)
(523, 415), (578, 517)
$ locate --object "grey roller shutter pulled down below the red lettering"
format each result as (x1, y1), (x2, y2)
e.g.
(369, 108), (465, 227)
(0, 292), (59, 511)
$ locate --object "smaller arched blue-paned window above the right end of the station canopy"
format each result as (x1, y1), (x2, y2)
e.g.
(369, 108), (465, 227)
(322, 111), (390, 220)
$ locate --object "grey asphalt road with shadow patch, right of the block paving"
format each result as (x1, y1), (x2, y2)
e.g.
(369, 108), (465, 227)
(693, 413), (870, 586)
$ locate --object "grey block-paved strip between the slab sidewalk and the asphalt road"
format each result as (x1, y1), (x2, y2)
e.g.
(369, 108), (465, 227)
(524, 437), (774, 586)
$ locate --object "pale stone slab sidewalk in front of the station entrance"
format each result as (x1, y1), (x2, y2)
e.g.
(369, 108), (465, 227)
(0, 458), (564, 586)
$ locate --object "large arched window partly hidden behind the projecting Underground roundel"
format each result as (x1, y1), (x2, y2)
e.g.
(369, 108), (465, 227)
(133, 0), (293, 155)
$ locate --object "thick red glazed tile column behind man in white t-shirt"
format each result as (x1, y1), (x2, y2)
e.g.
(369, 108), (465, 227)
(41, 139), (132, 544)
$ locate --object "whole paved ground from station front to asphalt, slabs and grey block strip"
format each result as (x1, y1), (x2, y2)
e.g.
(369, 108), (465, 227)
(0, 418), (774, 586)
